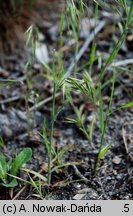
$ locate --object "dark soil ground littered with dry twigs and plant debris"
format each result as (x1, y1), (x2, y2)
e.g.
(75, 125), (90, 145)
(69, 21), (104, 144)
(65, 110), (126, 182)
(0, 0), (133, 200)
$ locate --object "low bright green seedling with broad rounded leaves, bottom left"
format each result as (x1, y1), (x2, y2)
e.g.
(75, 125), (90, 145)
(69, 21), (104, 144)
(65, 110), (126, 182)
(0, 148), (32, 187)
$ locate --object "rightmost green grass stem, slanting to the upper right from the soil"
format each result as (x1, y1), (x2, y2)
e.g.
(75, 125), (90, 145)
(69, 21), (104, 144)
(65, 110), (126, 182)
(95, 1), (133, 170)
